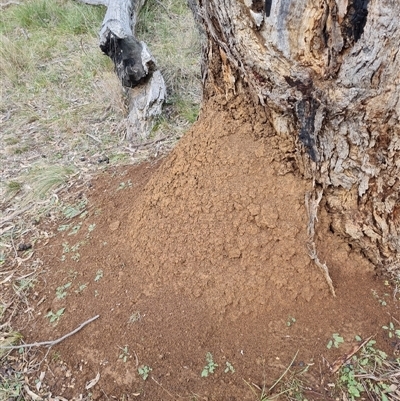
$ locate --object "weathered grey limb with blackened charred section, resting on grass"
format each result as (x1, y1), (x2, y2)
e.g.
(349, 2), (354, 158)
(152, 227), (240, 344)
(80, 0), (166, 139)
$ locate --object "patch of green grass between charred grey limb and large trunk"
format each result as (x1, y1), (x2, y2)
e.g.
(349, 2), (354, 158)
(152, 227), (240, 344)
(136, 0), (202, 117)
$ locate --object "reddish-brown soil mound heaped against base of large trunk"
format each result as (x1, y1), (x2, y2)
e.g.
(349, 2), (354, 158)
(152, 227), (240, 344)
(24, 93), (398, 400)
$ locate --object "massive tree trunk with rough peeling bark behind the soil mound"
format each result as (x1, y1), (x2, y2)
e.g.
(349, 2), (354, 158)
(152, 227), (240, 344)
(193, 0), (400, 275)
